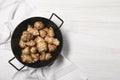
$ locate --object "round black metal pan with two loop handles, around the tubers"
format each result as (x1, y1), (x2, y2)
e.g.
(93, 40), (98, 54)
(9, 13), (64, 71)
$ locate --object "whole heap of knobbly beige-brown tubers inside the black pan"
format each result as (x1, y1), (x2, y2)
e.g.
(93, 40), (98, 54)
(19, 21), (60, 63)
